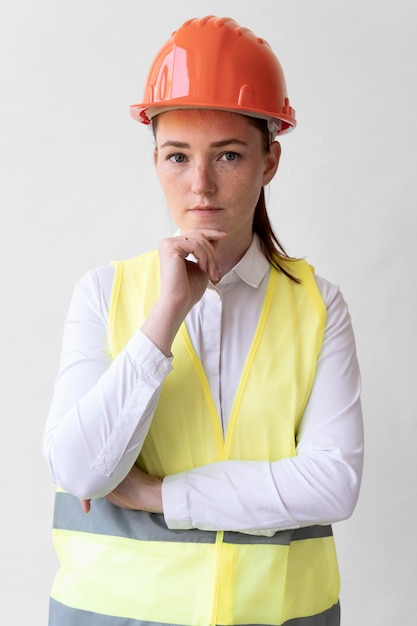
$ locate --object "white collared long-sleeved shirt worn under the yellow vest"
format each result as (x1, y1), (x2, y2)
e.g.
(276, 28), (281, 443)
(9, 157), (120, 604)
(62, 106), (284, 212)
(43, 236), (363, 534)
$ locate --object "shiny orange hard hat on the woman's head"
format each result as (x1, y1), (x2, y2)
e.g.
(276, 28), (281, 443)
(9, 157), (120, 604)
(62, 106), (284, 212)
(130, 15), (296, 134)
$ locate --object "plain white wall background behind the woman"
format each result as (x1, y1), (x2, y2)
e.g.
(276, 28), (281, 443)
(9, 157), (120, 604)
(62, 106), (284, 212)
(0, 0), (417, 626)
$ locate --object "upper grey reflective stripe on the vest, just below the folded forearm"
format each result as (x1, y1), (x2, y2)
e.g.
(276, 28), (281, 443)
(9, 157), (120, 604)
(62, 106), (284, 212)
(54, 493), (333, 546)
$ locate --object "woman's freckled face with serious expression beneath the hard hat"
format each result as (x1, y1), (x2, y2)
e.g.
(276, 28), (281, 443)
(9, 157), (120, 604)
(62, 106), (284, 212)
(155, 109), (279, 247)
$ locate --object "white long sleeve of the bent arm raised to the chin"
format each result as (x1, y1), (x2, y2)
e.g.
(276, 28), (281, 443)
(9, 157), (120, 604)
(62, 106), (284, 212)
(42, 266), (172, 498)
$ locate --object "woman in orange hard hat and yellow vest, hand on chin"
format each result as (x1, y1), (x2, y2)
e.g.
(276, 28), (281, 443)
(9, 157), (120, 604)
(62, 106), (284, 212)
(43, 17), (363, 626)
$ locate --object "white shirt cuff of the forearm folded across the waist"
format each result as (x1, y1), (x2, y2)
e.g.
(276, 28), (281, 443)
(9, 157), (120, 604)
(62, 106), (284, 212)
(162, 472), (193, 530)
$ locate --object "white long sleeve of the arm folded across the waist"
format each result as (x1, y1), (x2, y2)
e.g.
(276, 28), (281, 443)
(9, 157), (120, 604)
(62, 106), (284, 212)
(163, 280), (363, 534)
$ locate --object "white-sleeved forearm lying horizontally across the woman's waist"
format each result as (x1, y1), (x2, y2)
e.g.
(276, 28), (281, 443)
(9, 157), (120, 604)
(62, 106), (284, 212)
(162, 442), (361, 534)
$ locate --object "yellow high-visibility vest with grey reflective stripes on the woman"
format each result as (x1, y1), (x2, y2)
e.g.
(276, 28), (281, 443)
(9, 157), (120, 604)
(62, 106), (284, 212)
(51, 252), (339, 626)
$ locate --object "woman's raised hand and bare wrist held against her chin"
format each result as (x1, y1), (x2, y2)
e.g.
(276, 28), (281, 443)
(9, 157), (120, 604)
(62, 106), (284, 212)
(142, 229), (227, 356)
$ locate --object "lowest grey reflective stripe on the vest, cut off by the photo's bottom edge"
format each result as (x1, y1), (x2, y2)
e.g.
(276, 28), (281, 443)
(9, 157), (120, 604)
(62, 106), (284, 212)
(48, 599), (340, 626)
